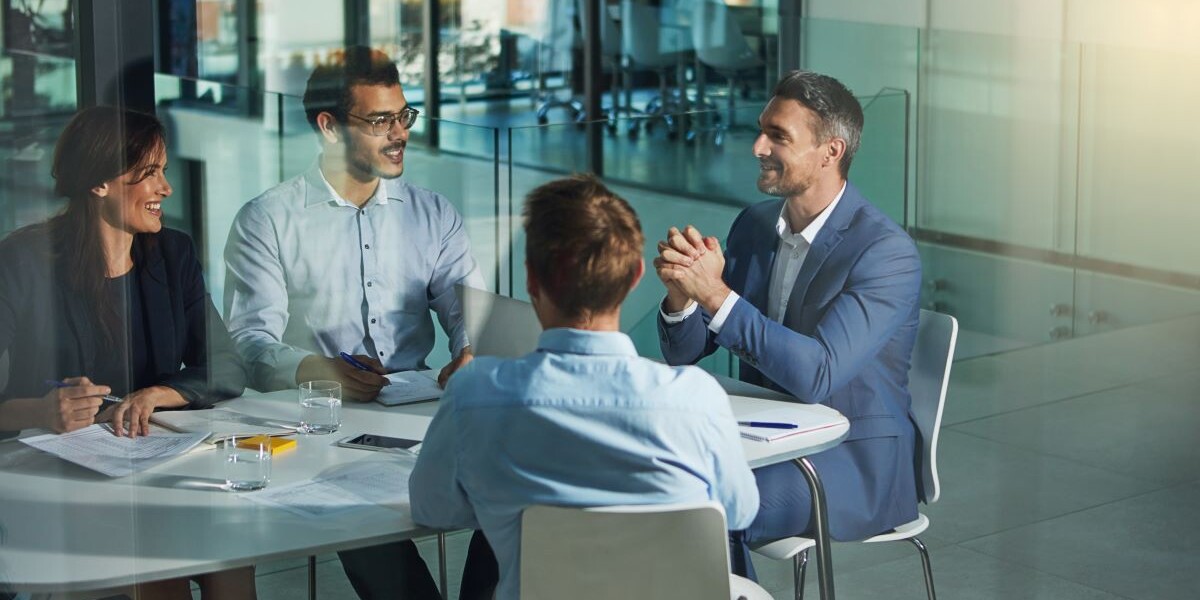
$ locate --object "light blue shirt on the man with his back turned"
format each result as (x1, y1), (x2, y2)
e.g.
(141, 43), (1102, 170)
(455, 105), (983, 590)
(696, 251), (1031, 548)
(409, 329), (758, 600)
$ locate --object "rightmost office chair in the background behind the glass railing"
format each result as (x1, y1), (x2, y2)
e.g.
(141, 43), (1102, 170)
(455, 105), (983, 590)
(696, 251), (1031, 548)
(688, 0), (764, 146)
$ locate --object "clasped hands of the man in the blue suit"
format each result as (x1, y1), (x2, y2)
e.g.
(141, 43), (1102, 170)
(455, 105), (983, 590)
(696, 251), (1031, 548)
(654, 226), (730, 314)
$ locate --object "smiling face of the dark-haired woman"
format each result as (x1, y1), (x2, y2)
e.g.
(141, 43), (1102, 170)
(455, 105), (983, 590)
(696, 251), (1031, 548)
(92, 144), (172, 234)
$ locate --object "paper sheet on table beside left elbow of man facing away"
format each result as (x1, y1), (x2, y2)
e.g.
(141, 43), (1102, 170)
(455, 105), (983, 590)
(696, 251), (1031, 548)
(242, 460), (414, 517)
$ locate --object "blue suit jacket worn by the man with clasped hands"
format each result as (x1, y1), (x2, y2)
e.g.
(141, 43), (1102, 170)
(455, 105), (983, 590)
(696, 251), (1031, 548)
(659, 184), (920, 540)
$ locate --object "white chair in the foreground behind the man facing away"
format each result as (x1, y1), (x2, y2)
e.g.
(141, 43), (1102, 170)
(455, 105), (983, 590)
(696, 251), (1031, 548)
(521, 502), (770, 600)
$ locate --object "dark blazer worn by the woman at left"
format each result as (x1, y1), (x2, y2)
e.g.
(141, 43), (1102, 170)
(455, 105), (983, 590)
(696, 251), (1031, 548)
(0, 224), (246, 428)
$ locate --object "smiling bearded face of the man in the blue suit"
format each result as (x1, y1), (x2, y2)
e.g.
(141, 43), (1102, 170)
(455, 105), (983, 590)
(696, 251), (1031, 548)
(754, 96), (840, 198)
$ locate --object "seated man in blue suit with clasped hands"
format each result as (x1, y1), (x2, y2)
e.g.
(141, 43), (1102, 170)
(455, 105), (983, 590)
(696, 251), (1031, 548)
(654, 71), (920, 577)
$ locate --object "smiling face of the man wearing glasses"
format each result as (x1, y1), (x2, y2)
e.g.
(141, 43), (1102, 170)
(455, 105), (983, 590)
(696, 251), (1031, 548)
(343, 85), (408, 181)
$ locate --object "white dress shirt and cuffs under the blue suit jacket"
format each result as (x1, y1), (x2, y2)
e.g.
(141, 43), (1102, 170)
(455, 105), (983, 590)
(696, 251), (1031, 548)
(659, 182), (846, 334)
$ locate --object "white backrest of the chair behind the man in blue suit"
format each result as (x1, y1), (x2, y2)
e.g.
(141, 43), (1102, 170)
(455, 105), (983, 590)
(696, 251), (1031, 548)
(908, 310), (959, 503)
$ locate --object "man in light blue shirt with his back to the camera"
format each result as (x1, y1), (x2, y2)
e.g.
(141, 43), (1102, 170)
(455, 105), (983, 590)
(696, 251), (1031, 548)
(409, 176), (758, 600)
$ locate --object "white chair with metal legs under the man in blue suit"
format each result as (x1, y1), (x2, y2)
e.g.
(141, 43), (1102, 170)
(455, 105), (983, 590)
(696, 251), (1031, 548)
(754, 310), (959, 600)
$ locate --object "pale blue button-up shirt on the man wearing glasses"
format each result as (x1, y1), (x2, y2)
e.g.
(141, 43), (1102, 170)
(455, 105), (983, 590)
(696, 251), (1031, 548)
(224, 161), (482, 390)
